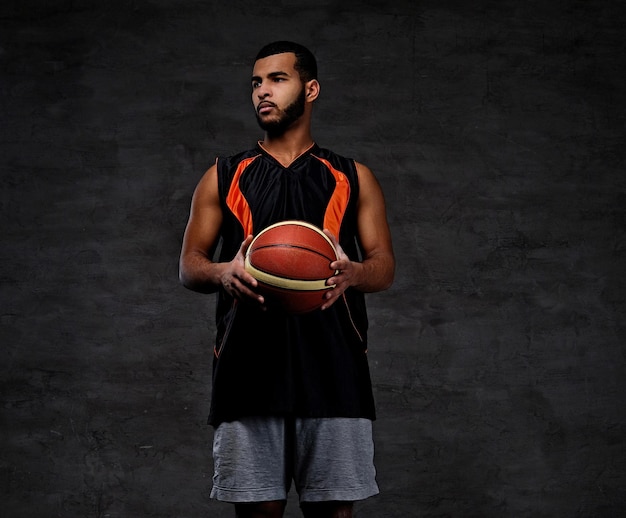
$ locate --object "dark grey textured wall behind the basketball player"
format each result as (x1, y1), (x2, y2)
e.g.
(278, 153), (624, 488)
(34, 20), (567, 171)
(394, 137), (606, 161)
(0, 0), (626, 518)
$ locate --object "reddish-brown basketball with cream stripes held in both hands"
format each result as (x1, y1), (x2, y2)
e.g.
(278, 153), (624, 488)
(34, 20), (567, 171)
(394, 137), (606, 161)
(245, 220), (338, 314)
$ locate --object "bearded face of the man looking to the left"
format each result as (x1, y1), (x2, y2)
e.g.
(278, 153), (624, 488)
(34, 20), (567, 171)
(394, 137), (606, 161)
(252, 52), (306, 135)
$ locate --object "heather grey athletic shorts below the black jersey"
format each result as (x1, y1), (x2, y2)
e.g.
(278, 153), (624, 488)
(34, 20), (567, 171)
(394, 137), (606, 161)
(211, 417), (378, 503)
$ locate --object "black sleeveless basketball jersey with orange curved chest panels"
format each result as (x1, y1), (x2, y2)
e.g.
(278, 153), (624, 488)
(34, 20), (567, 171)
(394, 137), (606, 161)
(209, 144), (375, 426)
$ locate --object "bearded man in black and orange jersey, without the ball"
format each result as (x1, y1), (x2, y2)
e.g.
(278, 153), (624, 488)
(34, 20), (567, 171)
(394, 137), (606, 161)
(180, 42), (395, 518)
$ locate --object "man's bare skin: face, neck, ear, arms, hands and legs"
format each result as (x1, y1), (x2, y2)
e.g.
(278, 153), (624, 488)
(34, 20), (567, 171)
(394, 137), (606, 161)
(180, 49), (395, 518)
